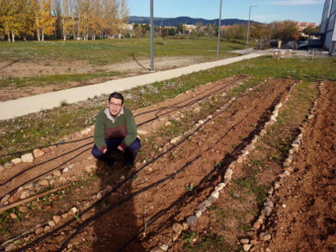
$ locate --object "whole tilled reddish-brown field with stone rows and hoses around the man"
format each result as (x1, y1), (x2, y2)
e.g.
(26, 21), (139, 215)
(0, 76), (336, 251)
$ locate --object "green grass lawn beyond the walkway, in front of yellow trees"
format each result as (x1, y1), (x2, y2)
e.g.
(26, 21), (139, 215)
(0, 37), (244, 66)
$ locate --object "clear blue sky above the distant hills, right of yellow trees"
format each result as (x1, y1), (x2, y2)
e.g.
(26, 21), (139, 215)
(128, 0), (325, 25)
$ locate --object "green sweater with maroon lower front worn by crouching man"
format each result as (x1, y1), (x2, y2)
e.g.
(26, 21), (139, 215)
(94, 107), (137, 152)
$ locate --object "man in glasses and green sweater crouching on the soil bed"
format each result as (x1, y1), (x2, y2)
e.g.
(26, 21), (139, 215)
(91, 92), (141, 168)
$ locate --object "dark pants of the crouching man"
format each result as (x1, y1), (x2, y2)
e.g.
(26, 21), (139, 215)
(91, 138), (141, 165)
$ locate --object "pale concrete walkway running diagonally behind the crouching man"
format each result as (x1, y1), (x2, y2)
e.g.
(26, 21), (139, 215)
(0, 53), (263, 120)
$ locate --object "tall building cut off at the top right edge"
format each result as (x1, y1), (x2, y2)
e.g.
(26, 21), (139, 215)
(320, 0), (336, 53)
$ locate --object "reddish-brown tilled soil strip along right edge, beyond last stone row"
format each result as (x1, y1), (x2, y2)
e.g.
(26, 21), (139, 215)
(269, 82), (336, 251)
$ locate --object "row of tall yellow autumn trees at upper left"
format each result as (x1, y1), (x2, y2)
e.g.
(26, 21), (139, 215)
(0, 0), (129, 42)
